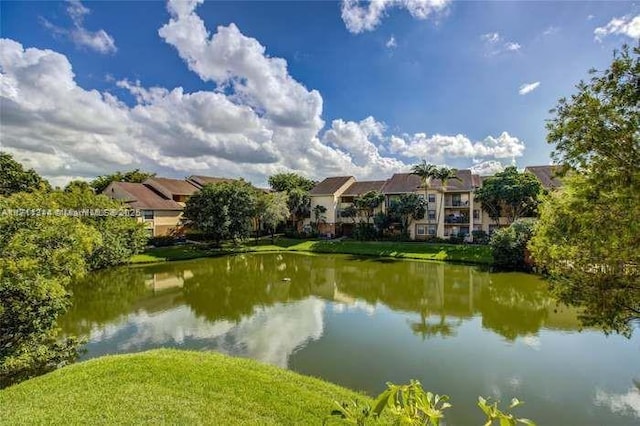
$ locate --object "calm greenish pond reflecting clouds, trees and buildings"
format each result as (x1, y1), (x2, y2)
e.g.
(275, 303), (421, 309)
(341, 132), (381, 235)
(61, 254), (640, 425)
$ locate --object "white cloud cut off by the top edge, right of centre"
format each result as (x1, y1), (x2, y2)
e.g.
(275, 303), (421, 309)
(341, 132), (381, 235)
(342, 0), (450, 34)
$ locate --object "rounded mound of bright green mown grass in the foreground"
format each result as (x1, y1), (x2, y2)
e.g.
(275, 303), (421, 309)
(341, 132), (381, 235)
(0, 349), (372, 425)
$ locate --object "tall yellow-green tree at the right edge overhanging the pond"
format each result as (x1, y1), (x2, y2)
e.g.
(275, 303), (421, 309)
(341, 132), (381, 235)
(530, 44), (640, 333)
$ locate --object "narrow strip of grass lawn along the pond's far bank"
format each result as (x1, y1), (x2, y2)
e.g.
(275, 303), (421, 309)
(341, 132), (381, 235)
(130, 238), (493, 265)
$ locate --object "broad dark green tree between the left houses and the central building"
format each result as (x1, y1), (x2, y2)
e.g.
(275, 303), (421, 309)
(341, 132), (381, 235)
(184, 180), (257, 245)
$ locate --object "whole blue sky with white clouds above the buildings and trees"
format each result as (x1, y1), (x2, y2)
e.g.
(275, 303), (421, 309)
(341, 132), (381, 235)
(0, 0), (640, 183)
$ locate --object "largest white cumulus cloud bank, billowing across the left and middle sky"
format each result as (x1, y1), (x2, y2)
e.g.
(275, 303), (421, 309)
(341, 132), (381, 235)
(0, 1), (524, 184)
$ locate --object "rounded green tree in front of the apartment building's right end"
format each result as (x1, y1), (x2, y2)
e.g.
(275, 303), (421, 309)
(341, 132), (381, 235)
(475, 166), (542, 224)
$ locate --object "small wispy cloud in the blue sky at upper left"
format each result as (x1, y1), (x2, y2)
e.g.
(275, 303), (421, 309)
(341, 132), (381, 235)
(42, 0), (117, 54)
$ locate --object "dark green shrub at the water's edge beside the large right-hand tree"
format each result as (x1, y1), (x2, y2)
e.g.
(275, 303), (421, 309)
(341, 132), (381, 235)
(489, 219), (535, 271)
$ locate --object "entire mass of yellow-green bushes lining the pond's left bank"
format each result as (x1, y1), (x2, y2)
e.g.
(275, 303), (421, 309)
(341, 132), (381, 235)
(0, 161), (146, 386)
